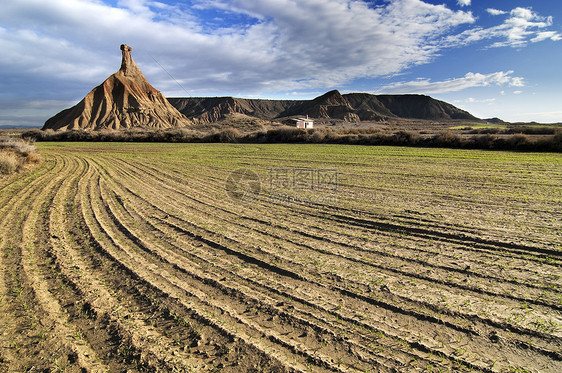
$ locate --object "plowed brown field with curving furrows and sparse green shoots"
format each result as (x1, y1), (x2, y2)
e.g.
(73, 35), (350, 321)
(0, 143), (562, 372)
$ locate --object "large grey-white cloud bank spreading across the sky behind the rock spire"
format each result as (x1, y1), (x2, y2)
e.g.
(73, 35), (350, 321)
(0, 0), (560, 97)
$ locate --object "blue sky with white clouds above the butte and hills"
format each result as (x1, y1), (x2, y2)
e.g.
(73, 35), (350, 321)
(0, 0), (562, 126)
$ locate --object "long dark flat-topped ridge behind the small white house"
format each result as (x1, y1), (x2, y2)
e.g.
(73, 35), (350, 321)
(168, 90), (478, 123)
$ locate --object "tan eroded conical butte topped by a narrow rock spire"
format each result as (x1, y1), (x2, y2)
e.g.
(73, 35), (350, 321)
(43, 44), (192, 130)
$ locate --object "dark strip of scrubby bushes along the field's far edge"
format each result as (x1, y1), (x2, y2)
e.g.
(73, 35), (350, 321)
(22, 126), (562, 152)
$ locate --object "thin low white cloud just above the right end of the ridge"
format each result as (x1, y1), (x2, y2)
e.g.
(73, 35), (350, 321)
(378, 71), (524, 94)
